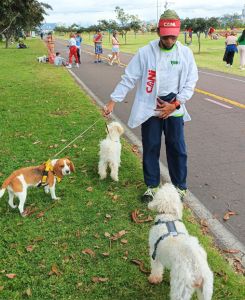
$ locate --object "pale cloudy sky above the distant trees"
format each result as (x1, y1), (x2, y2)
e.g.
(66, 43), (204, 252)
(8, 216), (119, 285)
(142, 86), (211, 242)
(42, 0), (245, 27)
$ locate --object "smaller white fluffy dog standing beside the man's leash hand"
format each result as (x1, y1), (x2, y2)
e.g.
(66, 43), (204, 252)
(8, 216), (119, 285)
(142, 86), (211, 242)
(98, 122), (124, 181)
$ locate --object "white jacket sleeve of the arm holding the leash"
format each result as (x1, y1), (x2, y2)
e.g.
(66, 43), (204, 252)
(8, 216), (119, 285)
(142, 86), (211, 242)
(111, 52), (143, 102)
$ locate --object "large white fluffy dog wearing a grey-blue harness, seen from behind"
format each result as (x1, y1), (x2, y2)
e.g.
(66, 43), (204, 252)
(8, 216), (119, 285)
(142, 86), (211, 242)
(148, 183), (213, 300)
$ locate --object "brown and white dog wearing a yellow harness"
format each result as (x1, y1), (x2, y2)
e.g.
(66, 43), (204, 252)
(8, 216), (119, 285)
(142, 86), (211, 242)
(0, 158), (75, 217)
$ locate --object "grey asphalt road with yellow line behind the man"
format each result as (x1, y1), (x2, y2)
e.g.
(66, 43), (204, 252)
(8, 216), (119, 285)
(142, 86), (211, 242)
(56, 40), (245, 244)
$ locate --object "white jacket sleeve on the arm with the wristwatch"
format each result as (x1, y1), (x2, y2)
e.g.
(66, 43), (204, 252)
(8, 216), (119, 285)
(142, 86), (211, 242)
(176, 50), (198, 104)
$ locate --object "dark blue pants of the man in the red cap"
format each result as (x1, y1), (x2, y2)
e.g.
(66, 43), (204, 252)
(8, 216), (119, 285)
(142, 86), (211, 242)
(141, 117), (187, 189)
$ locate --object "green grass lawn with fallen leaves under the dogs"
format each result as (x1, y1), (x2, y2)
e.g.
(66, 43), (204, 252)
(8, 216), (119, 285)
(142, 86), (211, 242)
(0, 40), (245, 300)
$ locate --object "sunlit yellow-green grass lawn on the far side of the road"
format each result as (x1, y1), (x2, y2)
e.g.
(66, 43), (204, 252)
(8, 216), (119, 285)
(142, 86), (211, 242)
(58, 33), (245, 76)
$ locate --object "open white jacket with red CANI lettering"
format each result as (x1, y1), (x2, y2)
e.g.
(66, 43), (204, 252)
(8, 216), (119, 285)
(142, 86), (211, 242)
(111, 39), (198, 128)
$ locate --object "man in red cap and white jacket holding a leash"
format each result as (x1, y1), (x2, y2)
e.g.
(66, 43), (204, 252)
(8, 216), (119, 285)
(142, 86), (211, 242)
(104, 10), (198, 202)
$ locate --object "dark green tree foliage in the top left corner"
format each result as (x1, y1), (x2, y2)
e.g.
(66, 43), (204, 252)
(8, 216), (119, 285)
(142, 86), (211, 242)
(0, 0), (52, 48)
